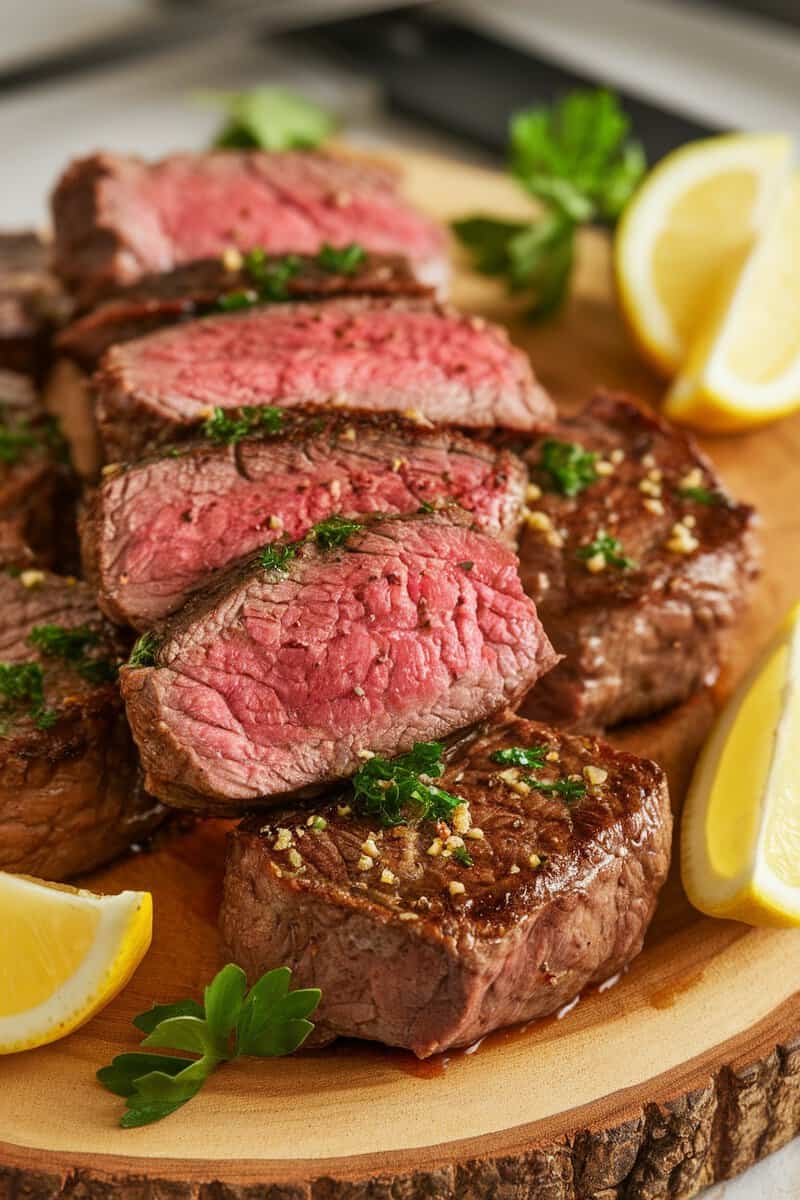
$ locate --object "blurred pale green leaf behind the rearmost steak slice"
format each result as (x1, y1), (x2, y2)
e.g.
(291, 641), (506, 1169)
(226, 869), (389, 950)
(201, 88), (337, 151)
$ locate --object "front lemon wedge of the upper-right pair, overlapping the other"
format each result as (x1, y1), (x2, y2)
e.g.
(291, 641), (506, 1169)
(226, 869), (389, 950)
(664, 174), (800, 432)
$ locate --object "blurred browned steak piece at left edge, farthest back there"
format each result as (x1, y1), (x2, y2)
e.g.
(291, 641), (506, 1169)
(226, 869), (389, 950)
(0, 233), (65, 376)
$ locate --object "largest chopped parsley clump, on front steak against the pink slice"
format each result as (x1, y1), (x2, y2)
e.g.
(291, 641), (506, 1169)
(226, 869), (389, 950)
(353, 742), (463, 827)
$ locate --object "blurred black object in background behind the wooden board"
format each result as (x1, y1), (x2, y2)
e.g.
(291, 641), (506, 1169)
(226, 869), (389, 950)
(276, 0), (719, 162)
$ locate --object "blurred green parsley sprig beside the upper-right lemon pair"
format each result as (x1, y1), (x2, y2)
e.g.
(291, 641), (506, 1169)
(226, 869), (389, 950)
(453, 89), (645, 318)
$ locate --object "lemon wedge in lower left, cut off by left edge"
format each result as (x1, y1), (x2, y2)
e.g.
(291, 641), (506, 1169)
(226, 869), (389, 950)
(0, 871), (152, 1054)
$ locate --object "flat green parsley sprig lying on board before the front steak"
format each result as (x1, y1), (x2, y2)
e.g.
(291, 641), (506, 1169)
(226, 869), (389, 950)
(97, 962), (321, 1129)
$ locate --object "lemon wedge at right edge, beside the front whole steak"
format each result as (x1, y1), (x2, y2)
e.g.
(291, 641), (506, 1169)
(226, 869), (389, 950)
(681, 605), (800, 926)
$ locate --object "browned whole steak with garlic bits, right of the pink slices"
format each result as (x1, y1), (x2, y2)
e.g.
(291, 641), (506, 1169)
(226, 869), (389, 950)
(519, 395), (757, 728)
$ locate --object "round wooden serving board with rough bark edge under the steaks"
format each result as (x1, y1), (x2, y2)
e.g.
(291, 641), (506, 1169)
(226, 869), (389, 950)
(0, 147), (800, 1200)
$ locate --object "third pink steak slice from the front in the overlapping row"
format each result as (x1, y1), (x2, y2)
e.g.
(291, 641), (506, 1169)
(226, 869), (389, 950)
(95, 299), (553, 462)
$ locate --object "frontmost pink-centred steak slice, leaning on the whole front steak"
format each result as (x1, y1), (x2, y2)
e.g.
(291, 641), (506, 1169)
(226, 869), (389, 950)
(121, 514), (554, 810)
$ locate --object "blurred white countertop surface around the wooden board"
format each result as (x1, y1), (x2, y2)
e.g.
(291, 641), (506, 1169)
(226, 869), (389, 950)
(0, 7), (800, 1200)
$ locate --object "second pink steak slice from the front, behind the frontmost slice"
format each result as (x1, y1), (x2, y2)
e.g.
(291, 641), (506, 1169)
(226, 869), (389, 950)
(80, 413), (528, 629)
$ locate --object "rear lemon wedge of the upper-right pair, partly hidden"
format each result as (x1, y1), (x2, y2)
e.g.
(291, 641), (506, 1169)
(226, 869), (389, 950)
(614, 133), (792, 376)
